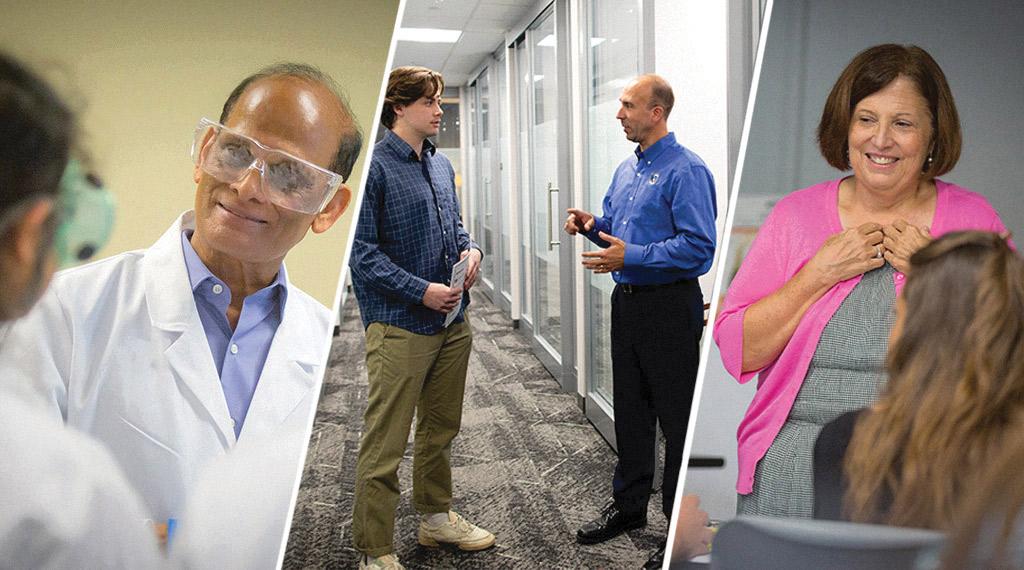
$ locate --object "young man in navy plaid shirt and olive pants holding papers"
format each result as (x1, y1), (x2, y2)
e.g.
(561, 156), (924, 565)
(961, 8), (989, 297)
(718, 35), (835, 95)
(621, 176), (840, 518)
(349, 67), (495, 569)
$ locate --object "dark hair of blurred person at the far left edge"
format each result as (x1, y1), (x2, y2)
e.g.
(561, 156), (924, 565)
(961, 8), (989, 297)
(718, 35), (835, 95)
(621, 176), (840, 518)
(0, 53), (74, 219)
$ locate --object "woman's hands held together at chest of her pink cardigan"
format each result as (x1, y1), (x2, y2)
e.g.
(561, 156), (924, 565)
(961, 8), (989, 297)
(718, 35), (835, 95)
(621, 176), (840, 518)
(811, 220), (932, 286)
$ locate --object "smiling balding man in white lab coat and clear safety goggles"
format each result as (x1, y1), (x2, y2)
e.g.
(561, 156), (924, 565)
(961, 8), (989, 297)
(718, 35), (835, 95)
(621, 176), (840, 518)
(0, 64), (361, 527)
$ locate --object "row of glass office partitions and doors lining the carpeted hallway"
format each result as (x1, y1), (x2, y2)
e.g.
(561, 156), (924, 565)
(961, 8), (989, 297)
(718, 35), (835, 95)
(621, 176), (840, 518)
(463, 0), (643, 444)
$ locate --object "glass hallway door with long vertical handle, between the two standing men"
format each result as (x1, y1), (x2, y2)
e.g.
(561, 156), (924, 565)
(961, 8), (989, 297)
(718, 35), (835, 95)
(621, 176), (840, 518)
(507, 2), (577, 392)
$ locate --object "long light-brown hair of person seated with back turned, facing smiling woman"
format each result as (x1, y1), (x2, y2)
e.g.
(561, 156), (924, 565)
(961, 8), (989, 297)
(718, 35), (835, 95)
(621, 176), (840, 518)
(846, 231), (1024, 528)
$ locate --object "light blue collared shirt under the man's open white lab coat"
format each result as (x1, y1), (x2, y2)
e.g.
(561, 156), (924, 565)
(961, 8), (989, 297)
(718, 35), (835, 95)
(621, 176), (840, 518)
(181, 231), (288, 438)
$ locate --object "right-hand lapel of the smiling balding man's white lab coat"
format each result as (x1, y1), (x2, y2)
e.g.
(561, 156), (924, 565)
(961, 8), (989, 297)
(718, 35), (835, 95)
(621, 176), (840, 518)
(240, 284), (328, 438)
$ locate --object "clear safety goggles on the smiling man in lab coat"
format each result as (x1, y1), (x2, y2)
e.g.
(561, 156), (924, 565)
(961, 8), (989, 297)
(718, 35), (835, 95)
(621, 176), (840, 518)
(191, 119), (344, 214)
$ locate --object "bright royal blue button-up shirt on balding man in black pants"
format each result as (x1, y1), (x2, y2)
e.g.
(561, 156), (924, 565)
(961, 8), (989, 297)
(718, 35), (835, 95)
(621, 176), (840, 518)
(586, 133), (718, 284)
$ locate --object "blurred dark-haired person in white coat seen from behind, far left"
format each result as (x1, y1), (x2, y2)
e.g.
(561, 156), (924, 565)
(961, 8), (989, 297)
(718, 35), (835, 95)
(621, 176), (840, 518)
(0, 54), (165, 568)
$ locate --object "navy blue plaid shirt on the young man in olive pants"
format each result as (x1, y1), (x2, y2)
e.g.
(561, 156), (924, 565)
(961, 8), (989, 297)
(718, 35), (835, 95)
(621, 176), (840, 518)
(348, 130), (479, 335)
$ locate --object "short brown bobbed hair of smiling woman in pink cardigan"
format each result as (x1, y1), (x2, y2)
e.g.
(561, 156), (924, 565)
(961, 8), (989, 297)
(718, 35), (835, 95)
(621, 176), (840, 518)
(818, 44), (962, 178)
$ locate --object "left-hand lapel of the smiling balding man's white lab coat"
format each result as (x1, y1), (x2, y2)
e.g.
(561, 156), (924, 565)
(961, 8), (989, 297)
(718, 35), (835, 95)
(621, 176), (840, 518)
(142, 211), (234, 448)
